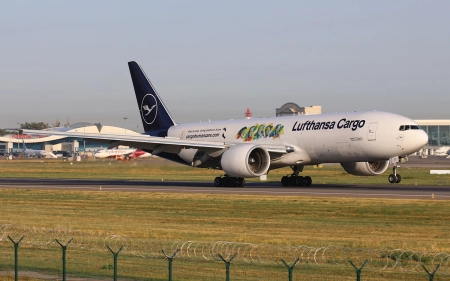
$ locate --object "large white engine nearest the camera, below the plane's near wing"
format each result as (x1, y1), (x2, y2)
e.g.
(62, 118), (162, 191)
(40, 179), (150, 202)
(220, 144), (270, 178)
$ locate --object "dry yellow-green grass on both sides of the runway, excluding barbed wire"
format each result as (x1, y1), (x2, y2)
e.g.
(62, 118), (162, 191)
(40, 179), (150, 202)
(0, 160), (450, 280)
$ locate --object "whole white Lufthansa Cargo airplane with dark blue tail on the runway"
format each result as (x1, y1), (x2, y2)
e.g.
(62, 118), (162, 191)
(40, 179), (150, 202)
(24, 61), (428, 187)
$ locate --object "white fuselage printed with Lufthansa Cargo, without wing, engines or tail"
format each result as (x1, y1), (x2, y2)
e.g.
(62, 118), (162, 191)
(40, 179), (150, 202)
(168, 111), (428, 166)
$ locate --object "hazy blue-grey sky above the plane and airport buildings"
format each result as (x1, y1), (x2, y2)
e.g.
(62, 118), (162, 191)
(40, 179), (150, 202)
(0, 0), (450, 131)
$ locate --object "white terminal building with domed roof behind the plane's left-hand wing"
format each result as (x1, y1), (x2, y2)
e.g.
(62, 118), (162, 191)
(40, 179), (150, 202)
(0, 122), (139, 154)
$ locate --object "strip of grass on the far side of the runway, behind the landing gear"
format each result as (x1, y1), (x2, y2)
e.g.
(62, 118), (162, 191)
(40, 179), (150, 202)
(0, 158), (450, 186)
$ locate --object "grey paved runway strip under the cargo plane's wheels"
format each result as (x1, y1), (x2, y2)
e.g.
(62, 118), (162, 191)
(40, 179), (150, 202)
(0, 179), (450, 200)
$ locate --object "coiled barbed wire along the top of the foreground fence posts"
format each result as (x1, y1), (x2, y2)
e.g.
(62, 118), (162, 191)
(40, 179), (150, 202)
(0, 224), (450, 275)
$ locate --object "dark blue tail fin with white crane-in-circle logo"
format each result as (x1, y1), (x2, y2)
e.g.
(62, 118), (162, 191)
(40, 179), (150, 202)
(128, 61), (175, 137)
